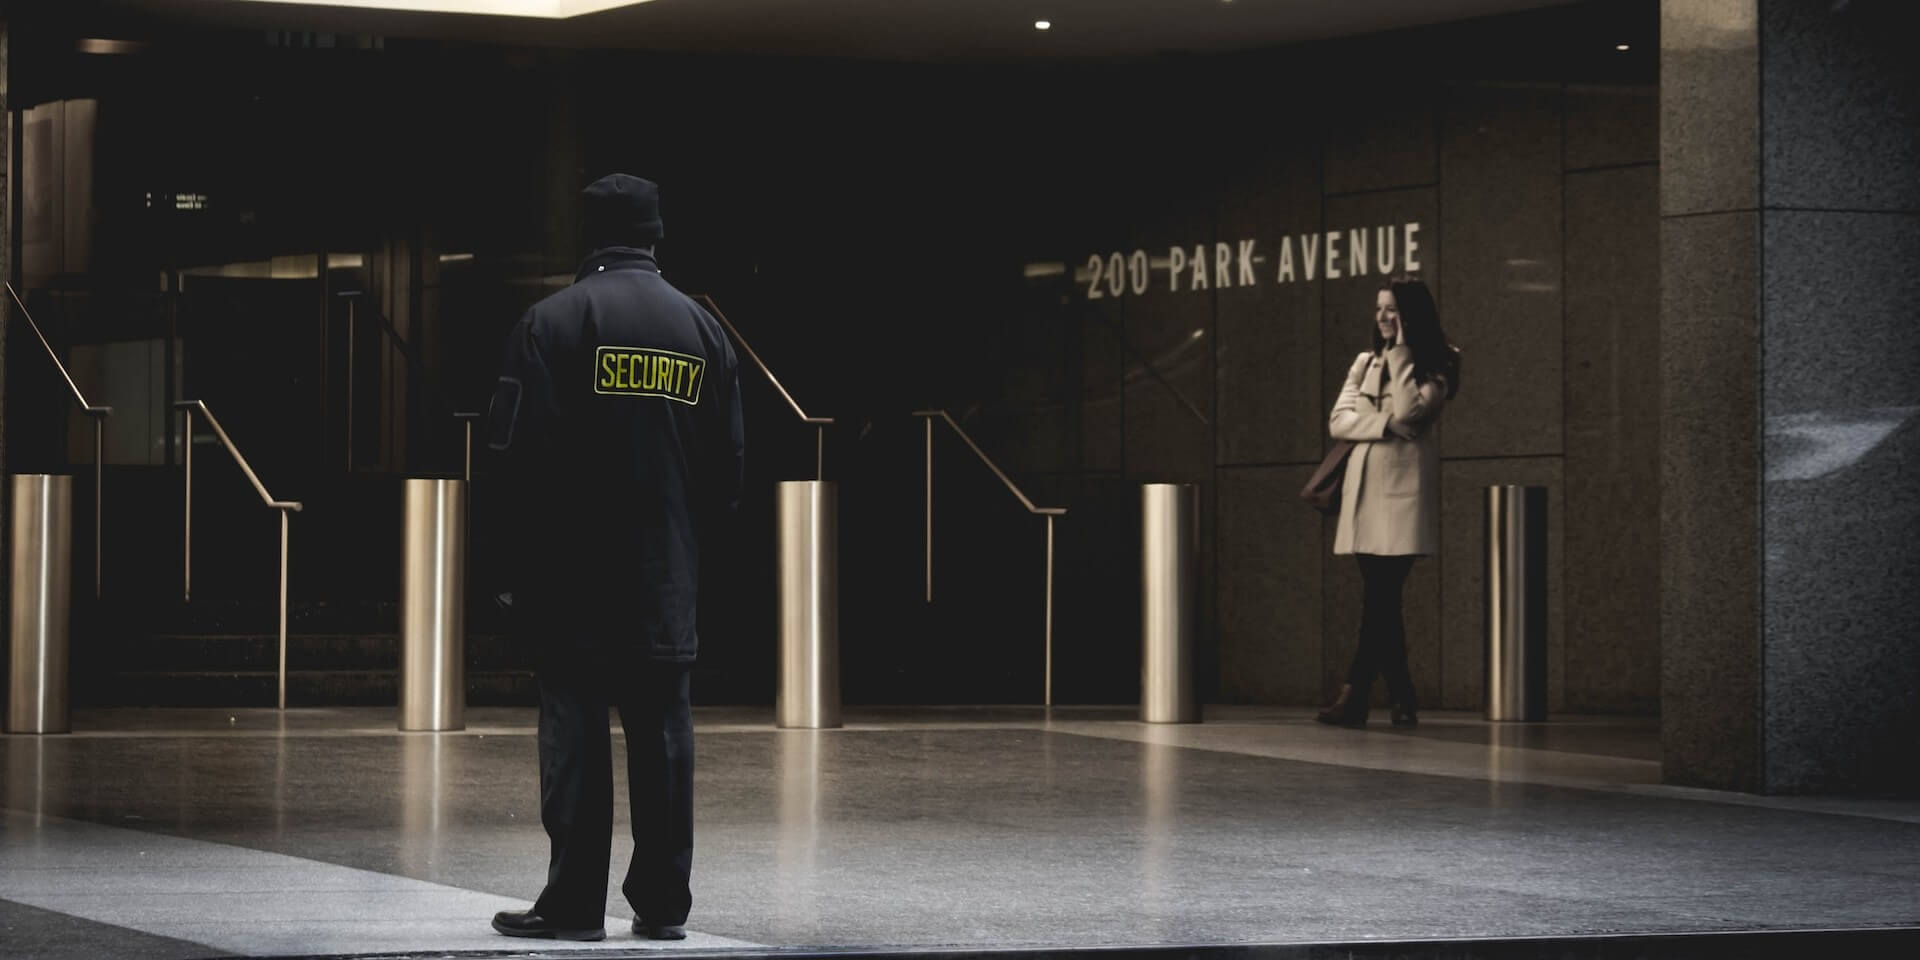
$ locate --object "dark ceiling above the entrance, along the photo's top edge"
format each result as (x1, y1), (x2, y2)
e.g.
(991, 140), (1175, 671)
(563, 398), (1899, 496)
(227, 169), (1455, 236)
(86, 0), (1589, 61)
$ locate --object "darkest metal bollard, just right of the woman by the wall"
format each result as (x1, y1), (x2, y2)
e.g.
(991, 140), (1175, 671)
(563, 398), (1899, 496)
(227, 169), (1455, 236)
(1486, 486), (1548, 722)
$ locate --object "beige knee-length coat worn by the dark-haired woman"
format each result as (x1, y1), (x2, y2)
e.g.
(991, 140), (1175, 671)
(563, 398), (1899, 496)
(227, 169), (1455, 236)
(1327, 346), (1448, 557)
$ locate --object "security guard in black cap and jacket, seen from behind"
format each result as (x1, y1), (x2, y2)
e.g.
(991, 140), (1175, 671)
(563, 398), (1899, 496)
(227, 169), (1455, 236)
(488, 175), (745, 941)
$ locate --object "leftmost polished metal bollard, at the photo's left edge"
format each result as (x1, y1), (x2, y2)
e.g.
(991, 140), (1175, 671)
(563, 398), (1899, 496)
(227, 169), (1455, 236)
(6, 474), (73, 733)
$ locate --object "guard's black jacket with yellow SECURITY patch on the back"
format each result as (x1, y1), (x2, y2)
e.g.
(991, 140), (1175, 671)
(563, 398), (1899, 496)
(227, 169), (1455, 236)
(488, 248), (745, 662)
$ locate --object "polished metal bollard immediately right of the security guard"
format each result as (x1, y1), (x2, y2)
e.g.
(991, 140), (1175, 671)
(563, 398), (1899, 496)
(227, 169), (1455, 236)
(774, 480), (841, 730)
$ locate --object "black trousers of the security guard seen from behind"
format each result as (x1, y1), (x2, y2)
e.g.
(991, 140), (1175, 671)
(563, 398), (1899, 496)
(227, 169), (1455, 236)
(534, 655), (693, 927)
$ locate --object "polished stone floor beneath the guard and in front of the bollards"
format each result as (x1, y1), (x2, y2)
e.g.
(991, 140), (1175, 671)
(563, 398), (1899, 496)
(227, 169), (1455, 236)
(0, 707), (1920, 958)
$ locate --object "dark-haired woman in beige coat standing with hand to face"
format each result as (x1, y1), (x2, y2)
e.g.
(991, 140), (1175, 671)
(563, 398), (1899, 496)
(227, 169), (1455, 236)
(1317, 276), (1459, 726)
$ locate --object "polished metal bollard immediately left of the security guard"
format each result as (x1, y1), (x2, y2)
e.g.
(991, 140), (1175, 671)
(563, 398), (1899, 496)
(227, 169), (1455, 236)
(399, 478), (467, 730)
